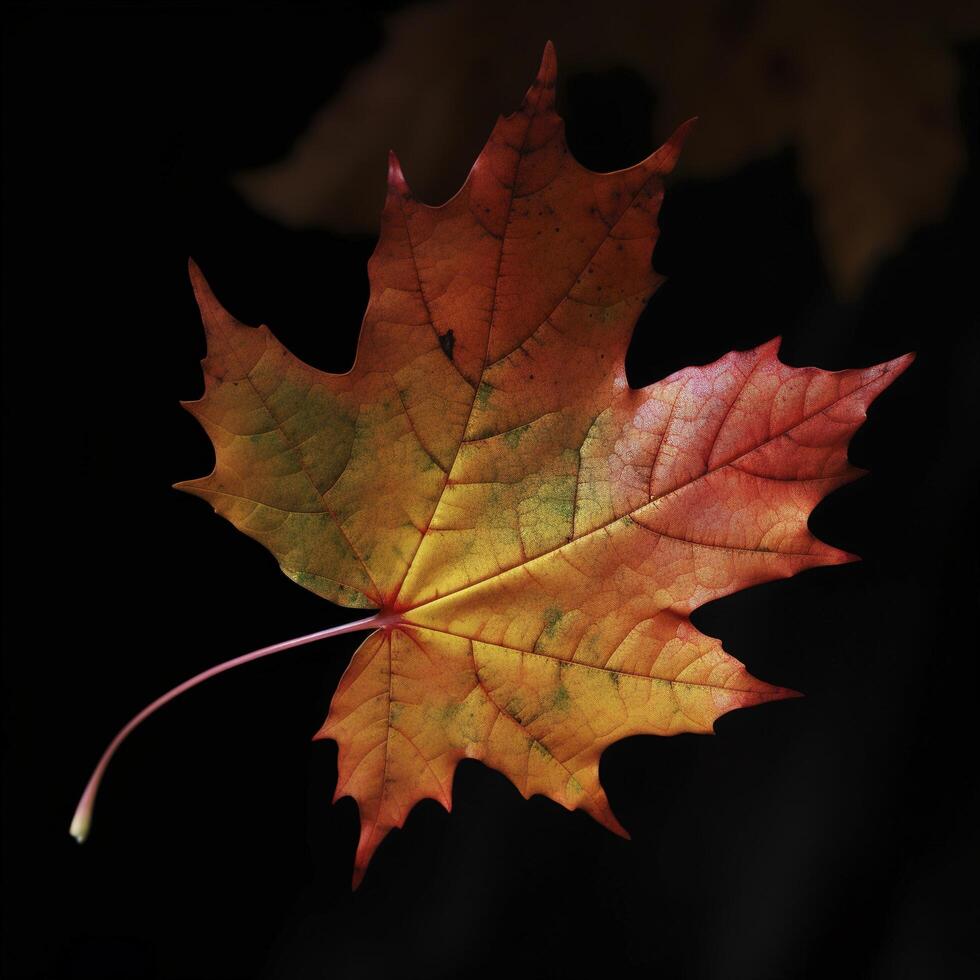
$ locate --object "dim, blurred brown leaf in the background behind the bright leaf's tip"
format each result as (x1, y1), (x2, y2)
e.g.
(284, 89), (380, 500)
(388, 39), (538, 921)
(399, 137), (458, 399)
(234, 0), (980, 299)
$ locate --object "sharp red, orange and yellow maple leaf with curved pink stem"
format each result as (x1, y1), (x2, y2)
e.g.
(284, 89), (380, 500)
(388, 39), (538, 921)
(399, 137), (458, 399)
(69, 44), (911, 885)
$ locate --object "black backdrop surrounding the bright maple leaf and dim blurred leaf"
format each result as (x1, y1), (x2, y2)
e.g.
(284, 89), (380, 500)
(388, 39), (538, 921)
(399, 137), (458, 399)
(3, 4), (980, 978)
